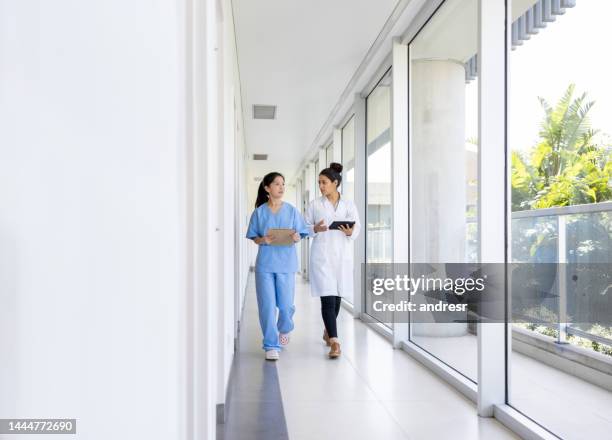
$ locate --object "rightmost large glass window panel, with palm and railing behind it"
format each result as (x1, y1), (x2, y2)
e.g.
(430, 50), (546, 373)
(508, 0), (612, 438)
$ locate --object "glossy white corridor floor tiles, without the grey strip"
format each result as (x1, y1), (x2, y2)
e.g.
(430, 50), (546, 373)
(226, 281), (517, 440)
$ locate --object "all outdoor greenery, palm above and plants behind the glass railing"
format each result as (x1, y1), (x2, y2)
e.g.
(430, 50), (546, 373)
(511, 84), (612, 356)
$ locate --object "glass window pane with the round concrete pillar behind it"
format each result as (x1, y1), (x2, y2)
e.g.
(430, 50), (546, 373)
(409, 0), (479, 382)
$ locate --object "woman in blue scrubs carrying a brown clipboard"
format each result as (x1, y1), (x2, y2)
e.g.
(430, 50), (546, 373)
(246, 172), (308, 360)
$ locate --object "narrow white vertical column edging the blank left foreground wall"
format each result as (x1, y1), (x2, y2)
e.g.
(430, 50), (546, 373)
(196, 1), (221, 438)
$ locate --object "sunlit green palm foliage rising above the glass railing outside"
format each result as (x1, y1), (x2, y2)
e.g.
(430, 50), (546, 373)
(511, 84), (612, 211)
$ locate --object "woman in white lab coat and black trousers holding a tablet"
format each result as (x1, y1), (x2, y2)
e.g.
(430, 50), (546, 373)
(305, 163), (361, 359)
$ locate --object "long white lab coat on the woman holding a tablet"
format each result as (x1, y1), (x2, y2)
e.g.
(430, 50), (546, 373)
(305, 196), (361, 297)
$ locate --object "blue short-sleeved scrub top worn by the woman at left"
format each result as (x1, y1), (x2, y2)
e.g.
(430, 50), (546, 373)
(246, 202), (308, 273)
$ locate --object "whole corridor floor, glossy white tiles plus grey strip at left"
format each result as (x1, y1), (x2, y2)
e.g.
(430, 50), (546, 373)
(221, 276), (519, 439)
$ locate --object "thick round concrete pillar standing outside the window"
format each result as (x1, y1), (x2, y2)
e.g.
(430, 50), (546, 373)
(411, 59), (467, 336)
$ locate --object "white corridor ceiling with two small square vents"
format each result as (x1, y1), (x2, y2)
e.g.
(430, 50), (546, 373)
(233, 0), (396, 189)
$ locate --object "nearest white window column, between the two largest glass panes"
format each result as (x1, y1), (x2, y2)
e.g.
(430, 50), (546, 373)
(478, 0), (510, 417)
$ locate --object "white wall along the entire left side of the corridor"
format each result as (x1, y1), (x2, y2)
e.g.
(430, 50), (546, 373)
(0, 0), (245, 439)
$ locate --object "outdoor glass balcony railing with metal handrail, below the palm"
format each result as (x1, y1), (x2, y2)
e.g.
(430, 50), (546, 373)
(511, 202), (612, 356)
